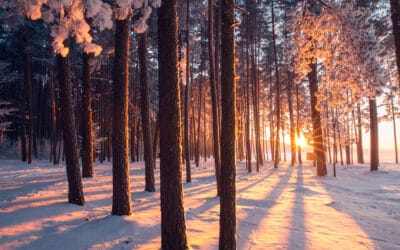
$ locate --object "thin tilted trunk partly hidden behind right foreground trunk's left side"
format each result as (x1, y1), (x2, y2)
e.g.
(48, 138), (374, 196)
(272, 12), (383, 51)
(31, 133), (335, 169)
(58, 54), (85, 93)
(208, 0), (221, 195)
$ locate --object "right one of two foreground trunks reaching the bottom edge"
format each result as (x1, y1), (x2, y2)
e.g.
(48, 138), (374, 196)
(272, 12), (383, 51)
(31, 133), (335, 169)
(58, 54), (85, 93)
(219, 0), (236, 249)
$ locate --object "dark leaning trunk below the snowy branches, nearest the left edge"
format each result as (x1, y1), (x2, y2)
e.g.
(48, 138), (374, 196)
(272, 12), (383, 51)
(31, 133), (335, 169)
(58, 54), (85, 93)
(57, 55), (85, 205)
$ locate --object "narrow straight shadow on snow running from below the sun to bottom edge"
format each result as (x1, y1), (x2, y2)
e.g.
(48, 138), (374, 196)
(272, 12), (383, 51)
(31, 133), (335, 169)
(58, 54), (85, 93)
(288, 166), (306, 250)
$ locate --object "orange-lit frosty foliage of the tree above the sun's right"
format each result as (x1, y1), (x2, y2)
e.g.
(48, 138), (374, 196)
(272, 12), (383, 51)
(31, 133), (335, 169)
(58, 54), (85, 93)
(292, 3), (387, 173)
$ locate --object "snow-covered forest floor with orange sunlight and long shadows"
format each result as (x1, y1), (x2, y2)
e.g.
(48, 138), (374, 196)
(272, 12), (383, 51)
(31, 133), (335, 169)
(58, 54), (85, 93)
(0, 160), (400, 250)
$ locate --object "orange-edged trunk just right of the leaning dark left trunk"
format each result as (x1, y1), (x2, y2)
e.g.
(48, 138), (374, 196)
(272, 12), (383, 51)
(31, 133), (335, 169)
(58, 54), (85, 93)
(82, 52), (94, 177)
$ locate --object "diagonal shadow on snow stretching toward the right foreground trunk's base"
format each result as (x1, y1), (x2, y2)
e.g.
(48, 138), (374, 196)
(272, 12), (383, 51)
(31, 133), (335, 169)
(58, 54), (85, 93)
(237, 167), (293, 249)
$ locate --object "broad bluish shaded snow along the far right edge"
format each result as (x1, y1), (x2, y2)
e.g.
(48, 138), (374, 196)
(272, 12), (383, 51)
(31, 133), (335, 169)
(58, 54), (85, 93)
(319, 166), (400, 249)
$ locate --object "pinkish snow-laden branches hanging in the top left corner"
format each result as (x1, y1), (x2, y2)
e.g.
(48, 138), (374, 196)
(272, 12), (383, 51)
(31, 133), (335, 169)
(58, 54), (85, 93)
(5, 0), (161, 56)
